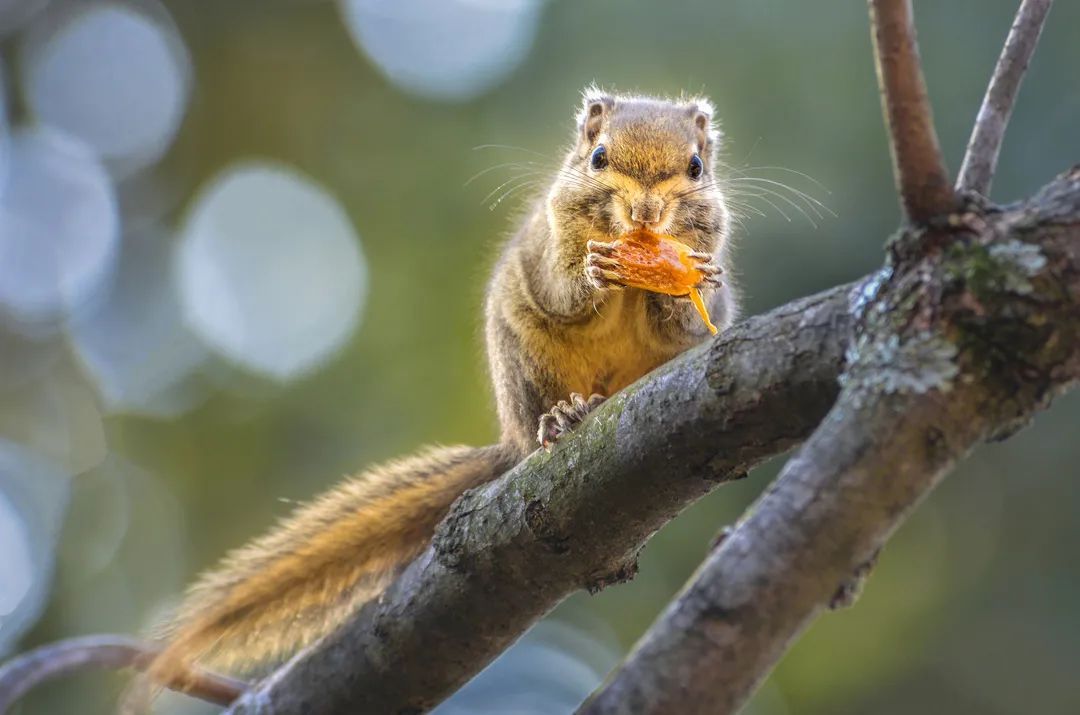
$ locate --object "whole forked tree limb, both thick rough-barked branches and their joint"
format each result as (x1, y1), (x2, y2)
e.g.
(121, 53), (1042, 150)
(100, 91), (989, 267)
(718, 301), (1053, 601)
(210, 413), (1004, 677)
(221, 171), (1080, 715)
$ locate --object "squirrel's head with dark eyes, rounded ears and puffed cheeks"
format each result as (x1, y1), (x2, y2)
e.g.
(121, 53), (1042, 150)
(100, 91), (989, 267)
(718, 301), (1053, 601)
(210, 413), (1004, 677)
(548, 87), (729, 247)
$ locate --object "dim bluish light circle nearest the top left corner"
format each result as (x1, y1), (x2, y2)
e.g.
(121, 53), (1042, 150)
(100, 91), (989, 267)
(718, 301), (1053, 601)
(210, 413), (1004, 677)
(22, 0), (190, 174)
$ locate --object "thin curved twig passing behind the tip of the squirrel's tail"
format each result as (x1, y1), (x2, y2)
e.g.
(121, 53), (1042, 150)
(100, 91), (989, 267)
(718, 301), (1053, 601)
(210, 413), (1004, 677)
(0, 634), (247, 714)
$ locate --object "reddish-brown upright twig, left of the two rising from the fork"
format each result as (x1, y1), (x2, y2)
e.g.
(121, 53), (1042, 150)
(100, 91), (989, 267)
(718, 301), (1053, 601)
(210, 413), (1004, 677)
(869, 0), (956, 224)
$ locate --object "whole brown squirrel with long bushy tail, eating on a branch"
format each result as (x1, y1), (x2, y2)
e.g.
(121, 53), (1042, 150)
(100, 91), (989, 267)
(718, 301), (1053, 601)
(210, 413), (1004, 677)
(139, 86), (738, 699)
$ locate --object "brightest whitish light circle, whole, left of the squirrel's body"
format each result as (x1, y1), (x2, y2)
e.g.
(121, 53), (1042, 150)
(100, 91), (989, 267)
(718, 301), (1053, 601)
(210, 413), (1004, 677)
(177, 162), (367, 380)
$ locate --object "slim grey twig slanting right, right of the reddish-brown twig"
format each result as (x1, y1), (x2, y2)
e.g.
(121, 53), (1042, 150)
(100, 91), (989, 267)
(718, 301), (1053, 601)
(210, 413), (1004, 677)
(956, 0), (1053, 197)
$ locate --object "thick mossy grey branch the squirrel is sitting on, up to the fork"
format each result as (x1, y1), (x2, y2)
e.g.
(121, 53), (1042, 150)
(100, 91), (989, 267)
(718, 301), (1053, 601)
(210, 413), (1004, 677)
(223, 286), (851, 715)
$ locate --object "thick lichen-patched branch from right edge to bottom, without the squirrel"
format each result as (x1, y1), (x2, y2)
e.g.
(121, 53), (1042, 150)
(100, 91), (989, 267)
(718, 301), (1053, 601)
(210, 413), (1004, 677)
(580, 170), (1080, 715)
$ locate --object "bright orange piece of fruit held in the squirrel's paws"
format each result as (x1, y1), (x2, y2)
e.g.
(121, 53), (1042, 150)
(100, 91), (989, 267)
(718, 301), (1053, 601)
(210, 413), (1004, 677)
(611, 229), (717, 335)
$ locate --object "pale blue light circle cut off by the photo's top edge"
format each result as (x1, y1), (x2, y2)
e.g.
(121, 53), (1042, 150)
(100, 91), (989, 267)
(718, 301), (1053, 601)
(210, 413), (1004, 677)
(341, 0), (542, 100)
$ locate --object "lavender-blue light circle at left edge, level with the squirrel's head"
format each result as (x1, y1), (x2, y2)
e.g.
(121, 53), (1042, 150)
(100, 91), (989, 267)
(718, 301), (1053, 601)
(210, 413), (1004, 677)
(0, 127), (120, 322)
